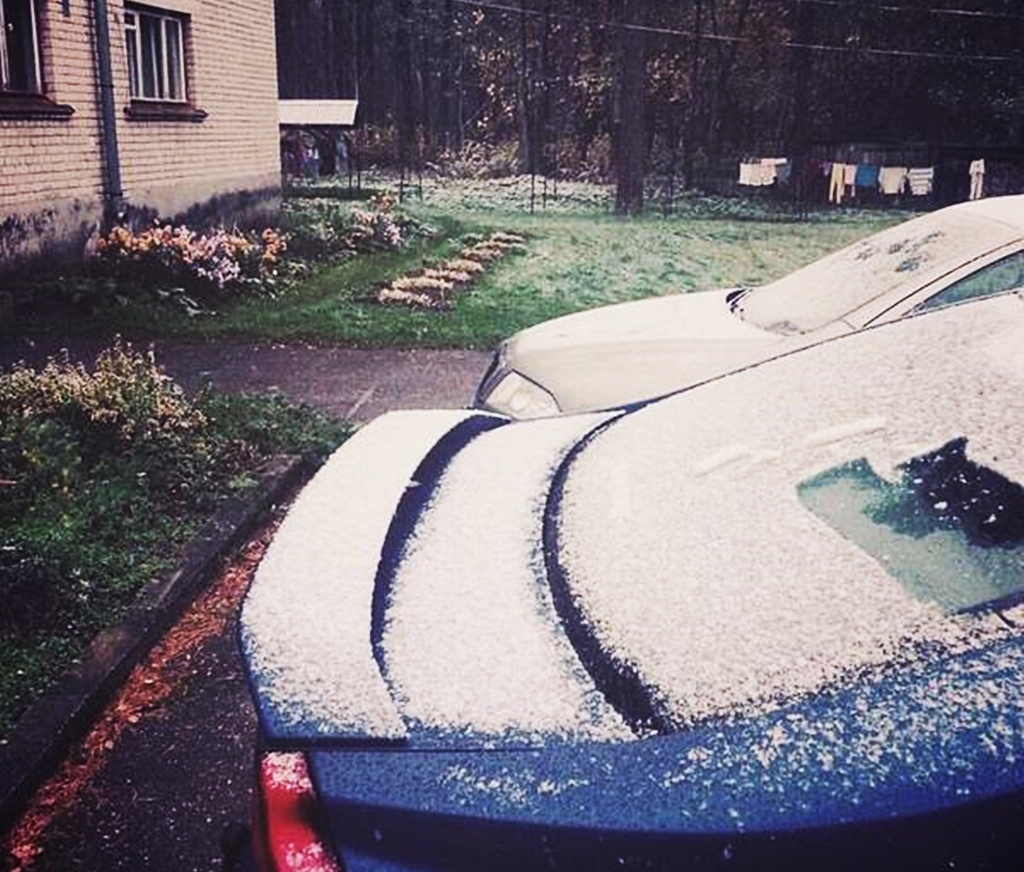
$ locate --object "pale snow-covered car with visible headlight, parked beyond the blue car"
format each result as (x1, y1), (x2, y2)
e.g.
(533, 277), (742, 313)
(474, 195), (1024, 418)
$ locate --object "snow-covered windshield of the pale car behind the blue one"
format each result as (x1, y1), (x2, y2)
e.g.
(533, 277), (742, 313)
(734, 212), (1016, 334)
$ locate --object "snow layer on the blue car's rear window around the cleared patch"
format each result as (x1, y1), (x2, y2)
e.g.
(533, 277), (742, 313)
(558, 295), (1024, 726)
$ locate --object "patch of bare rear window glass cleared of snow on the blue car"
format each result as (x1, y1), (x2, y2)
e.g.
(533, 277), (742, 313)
(798, 438), (1024, 612)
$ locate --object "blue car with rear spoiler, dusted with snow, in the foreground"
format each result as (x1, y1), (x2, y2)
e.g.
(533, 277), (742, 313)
(234, 293), (1024, 872)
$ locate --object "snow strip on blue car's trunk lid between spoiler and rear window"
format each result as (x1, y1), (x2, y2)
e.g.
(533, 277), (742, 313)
(383, 415), (633, 743)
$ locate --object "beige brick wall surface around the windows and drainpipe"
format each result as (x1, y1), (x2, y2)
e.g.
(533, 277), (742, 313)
(0, 0), (281, 267)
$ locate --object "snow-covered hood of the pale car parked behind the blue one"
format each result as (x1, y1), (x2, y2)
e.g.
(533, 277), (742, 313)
(500, 291), (809, 411)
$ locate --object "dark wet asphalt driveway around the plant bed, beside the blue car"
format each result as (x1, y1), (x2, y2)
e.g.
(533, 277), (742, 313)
(0, 340), (487, 872)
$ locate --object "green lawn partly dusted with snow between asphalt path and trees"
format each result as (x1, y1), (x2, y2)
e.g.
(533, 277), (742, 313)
(175, 189), (906, 349)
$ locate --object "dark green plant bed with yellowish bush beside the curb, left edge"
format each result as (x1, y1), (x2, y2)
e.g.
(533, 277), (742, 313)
(0, 344), (347, 733)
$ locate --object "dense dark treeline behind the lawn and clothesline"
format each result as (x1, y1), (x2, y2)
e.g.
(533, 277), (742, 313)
(278, 0), (1024, 206)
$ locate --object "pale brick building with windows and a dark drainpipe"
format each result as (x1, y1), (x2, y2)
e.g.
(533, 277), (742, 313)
(0, 0), (281, 273)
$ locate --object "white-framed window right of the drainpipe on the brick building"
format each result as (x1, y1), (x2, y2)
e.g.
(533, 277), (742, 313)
(124, 5), (188, 103)
